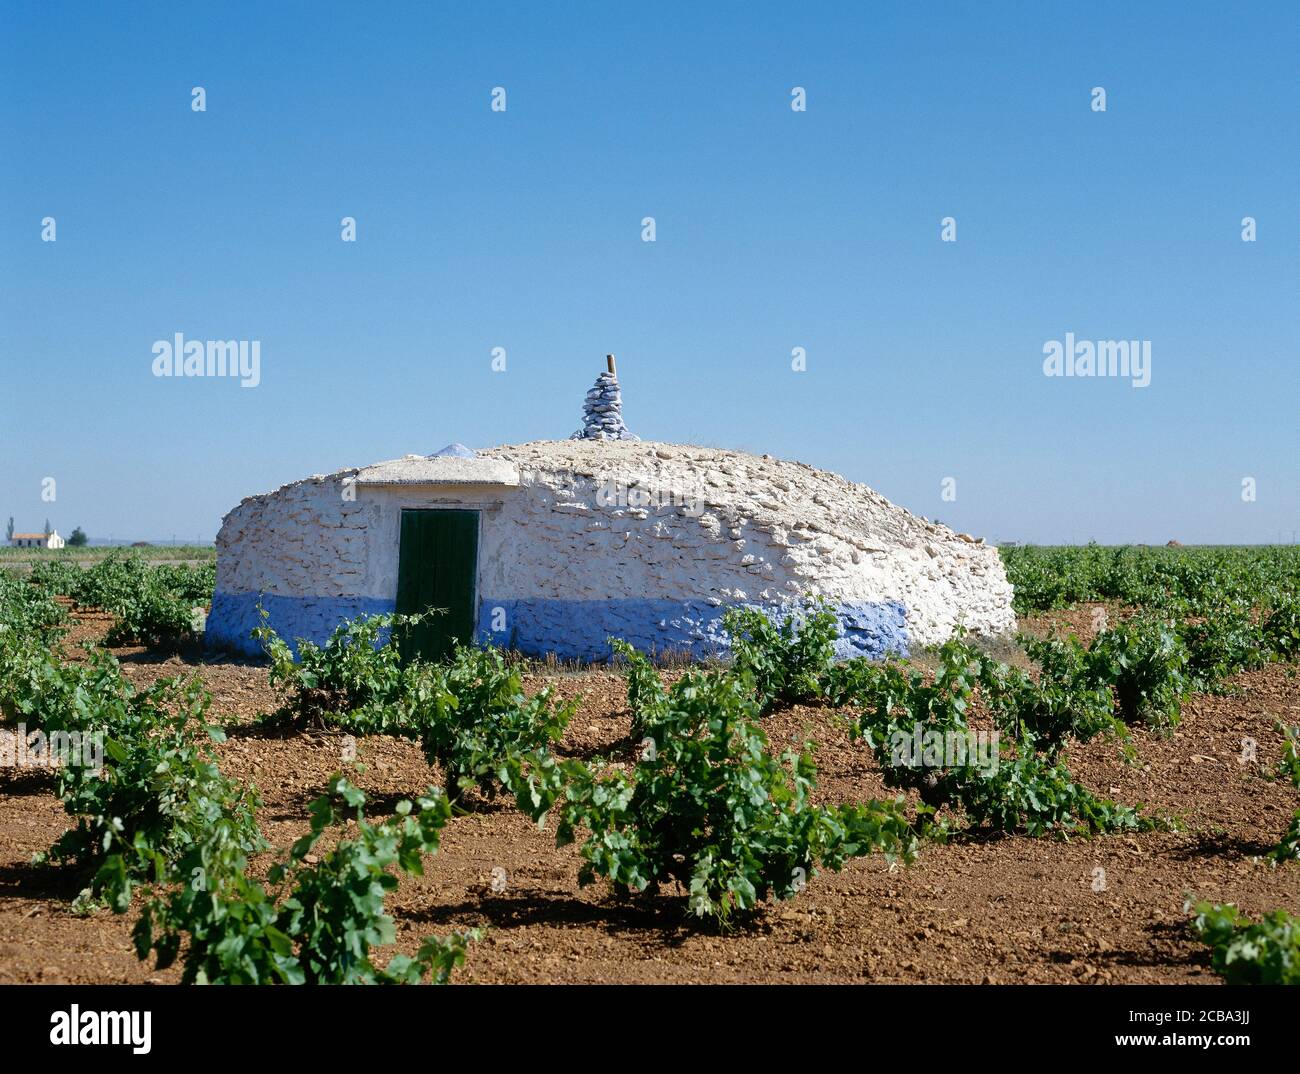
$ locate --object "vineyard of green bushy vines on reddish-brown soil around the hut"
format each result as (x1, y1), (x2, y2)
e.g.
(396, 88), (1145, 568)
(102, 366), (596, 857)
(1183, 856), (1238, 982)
(0, 546), (1300, 984)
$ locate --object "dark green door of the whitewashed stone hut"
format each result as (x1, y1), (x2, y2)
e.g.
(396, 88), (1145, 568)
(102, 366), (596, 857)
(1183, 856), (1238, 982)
(398, 511), (478, 661)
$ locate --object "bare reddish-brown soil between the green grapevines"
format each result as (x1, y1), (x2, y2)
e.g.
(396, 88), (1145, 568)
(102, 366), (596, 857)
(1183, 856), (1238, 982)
(0, 609), (1300, 983)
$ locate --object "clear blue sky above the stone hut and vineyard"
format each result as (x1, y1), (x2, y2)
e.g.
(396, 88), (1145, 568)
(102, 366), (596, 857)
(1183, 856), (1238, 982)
(0, 3), (1300, 542)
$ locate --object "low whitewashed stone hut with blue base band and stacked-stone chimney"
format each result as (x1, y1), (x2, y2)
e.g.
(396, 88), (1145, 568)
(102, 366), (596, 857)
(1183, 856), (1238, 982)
(207, 359), (1015, 661)
